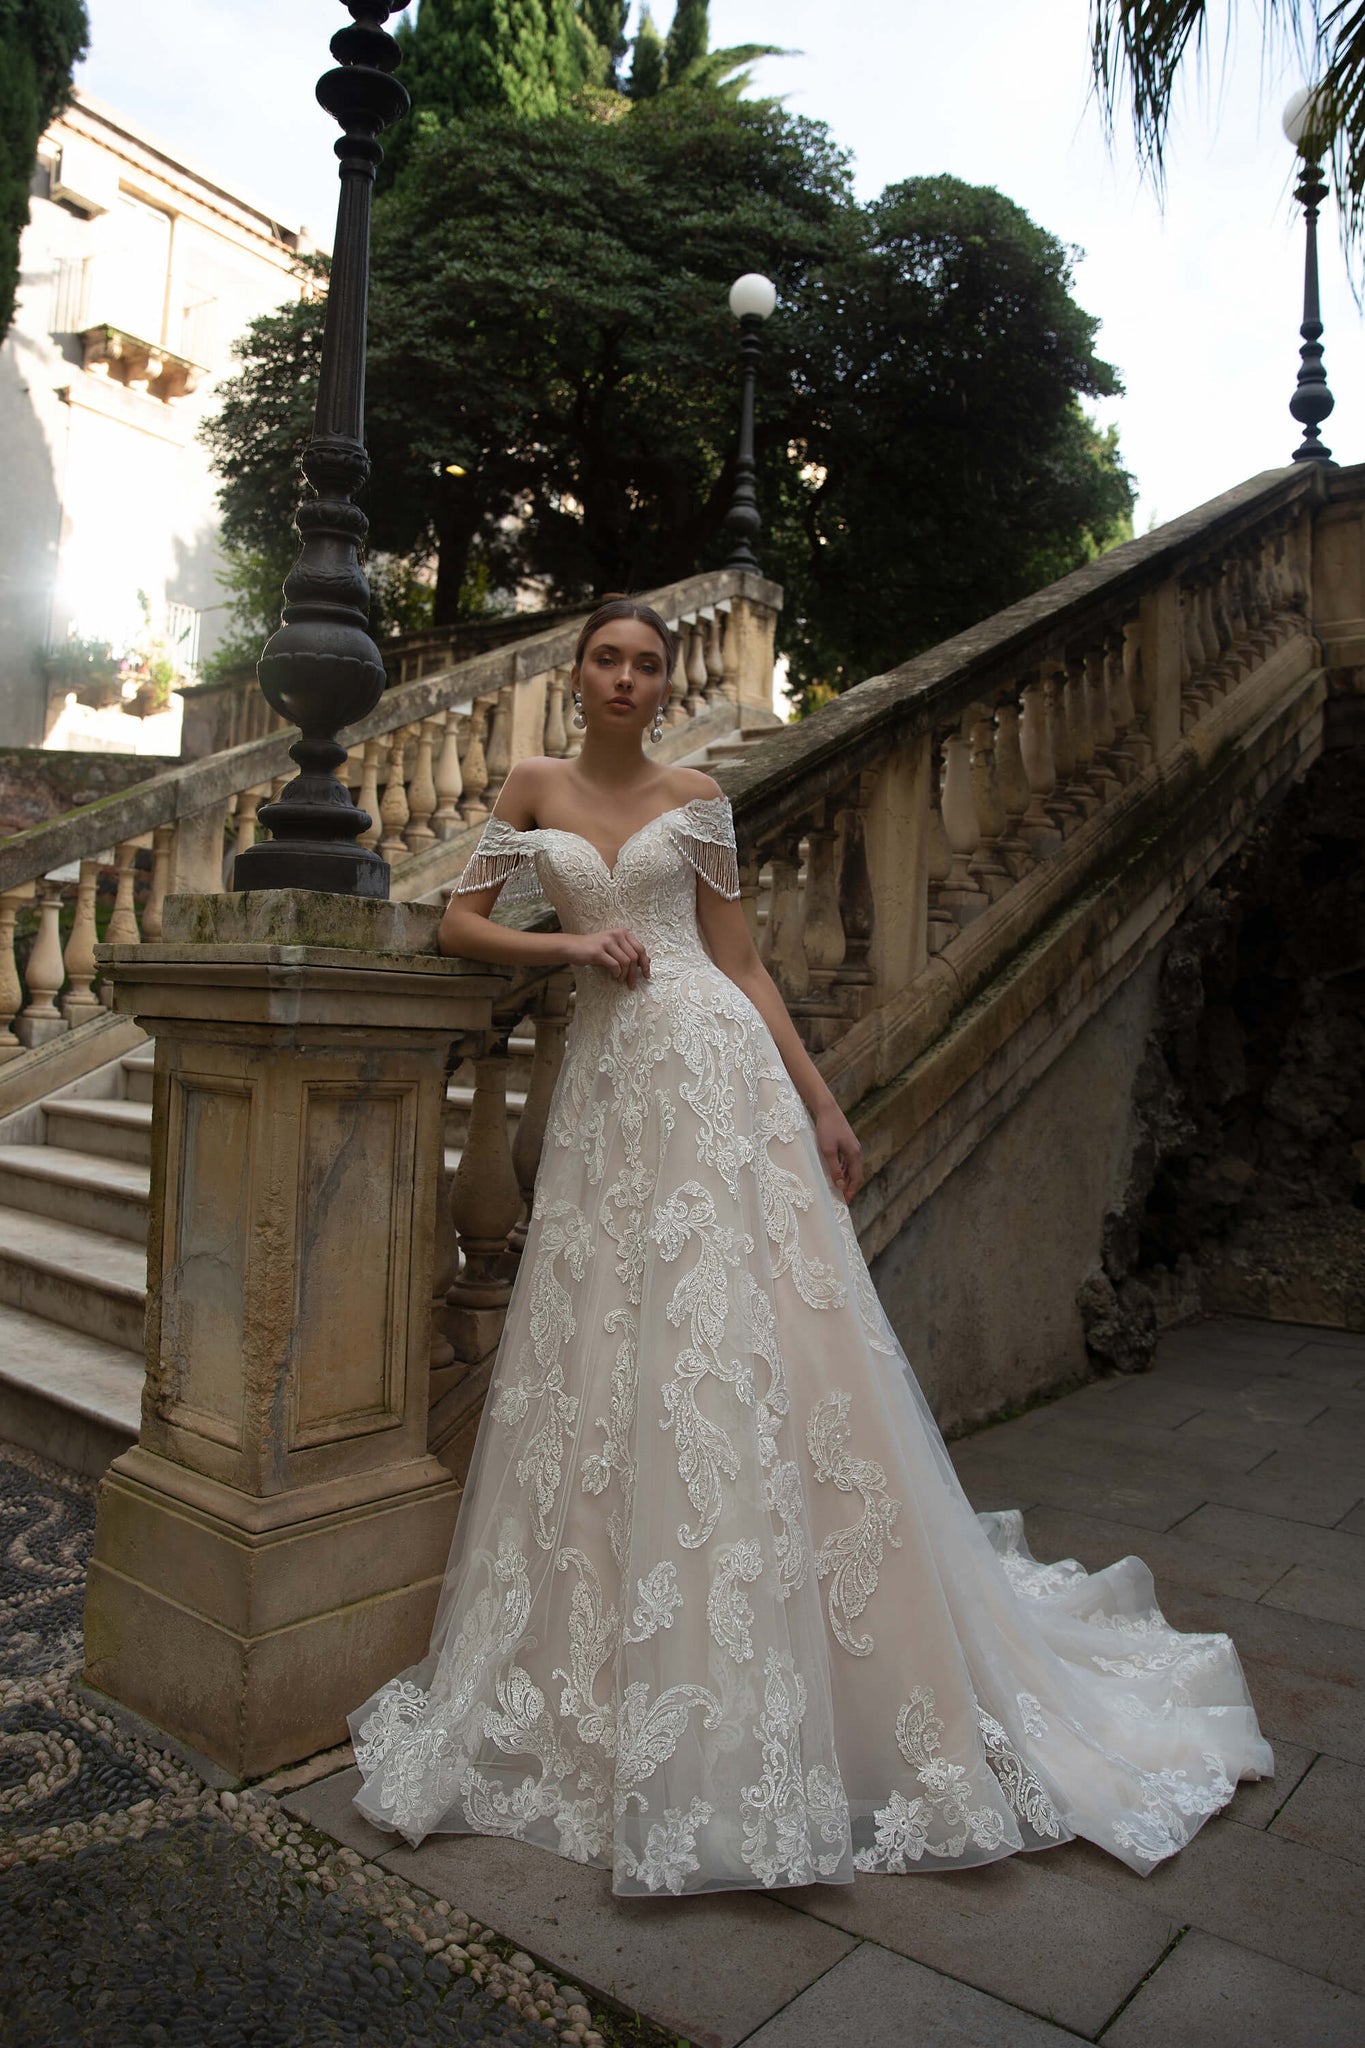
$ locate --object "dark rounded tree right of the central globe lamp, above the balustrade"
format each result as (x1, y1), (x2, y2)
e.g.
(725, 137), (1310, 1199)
(774, 176), (1132, 690)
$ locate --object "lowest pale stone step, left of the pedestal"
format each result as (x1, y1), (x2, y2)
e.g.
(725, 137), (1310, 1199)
(0, 1303), (143, 1479)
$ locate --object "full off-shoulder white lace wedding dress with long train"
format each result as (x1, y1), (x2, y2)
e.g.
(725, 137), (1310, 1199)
(348, 797), (1273, 1894)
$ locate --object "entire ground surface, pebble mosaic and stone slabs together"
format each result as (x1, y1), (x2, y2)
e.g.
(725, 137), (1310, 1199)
(0, 1319), (1365, 2048)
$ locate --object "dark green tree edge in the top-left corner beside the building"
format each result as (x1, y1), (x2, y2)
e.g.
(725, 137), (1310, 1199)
(0, 0), (90, 338)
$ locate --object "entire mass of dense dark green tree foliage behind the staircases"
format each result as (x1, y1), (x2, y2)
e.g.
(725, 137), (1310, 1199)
(207, 92), (1132, 690)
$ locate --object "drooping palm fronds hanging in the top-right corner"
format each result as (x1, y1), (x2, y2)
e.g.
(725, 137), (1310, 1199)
(1091, 0), (1365, 254)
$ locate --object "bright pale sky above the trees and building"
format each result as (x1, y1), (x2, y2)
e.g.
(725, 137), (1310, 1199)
(78, 0), (1365, 532)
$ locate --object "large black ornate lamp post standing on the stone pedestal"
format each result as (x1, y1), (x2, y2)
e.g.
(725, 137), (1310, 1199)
(233, 0), (409, 897)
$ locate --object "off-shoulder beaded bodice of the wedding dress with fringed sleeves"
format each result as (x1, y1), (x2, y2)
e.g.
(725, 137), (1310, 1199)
(454, 797), (739, 971)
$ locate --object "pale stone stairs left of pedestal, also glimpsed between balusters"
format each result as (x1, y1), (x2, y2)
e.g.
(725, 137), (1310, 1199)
(0, 723), (782, 1477)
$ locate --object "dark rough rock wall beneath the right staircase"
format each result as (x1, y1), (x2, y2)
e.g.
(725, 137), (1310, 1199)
(1083, 745), (1365, 1343)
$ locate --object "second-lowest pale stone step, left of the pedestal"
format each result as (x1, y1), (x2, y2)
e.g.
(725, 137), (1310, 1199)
(0, 1206), (147, 1352)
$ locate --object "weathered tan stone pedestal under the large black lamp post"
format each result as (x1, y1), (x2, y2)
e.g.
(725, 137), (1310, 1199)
(86, 891), (505, 1778)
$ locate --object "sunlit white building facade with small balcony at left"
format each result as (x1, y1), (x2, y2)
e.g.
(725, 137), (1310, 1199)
(0, 92), (311, 752)
